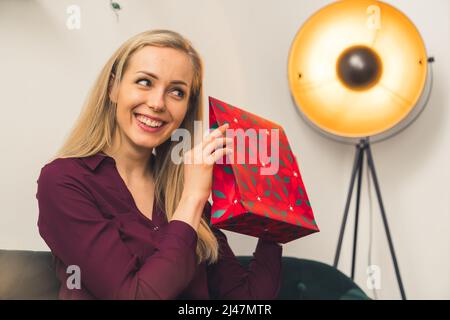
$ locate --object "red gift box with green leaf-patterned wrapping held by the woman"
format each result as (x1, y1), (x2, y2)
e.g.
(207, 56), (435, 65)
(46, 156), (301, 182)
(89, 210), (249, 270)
(209, 97), (319, 243)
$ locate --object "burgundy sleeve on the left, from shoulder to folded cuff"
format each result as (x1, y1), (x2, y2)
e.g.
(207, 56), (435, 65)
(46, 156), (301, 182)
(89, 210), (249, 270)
(36, 164), (197, 299)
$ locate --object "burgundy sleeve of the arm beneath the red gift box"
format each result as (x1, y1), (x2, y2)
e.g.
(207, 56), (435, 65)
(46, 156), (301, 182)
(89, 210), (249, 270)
(207, 203), (282, 300)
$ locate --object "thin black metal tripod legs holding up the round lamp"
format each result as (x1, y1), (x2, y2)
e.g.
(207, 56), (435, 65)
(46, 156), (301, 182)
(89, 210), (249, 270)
(334, 138), (406, 300)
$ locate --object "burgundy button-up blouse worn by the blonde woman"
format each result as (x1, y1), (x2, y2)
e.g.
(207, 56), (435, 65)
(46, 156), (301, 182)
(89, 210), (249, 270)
(36, 153), (282, 299)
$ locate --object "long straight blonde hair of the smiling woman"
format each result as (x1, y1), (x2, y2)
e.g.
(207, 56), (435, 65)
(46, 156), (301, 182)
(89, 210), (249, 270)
(56, 30), (218, 263)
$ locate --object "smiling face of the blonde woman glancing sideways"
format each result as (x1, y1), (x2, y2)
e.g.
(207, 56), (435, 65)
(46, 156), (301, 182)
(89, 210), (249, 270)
(110, 46), (193, 151)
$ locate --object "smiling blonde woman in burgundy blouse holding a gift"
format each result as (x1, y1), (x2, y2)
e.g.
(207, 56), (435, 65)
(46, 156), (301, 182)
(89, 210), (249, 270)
(36, 30), (282, 299)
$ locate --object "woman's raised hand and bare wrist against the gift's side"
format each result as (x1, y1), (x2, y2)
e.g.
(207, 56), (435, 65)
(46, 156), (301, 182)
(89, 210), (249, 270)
(172, 124), (233, 230)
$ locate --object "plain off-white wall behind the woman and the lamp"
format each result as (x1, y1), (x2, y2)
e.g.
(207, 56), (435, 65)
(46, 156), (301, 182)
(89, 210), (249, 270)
(0, 0), (450, 299)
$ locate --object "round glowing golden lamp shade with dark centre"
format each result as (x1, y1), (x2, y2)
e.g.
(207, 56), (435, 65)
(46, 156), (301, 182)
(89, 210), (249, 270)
(288, 0), (428, 138)
